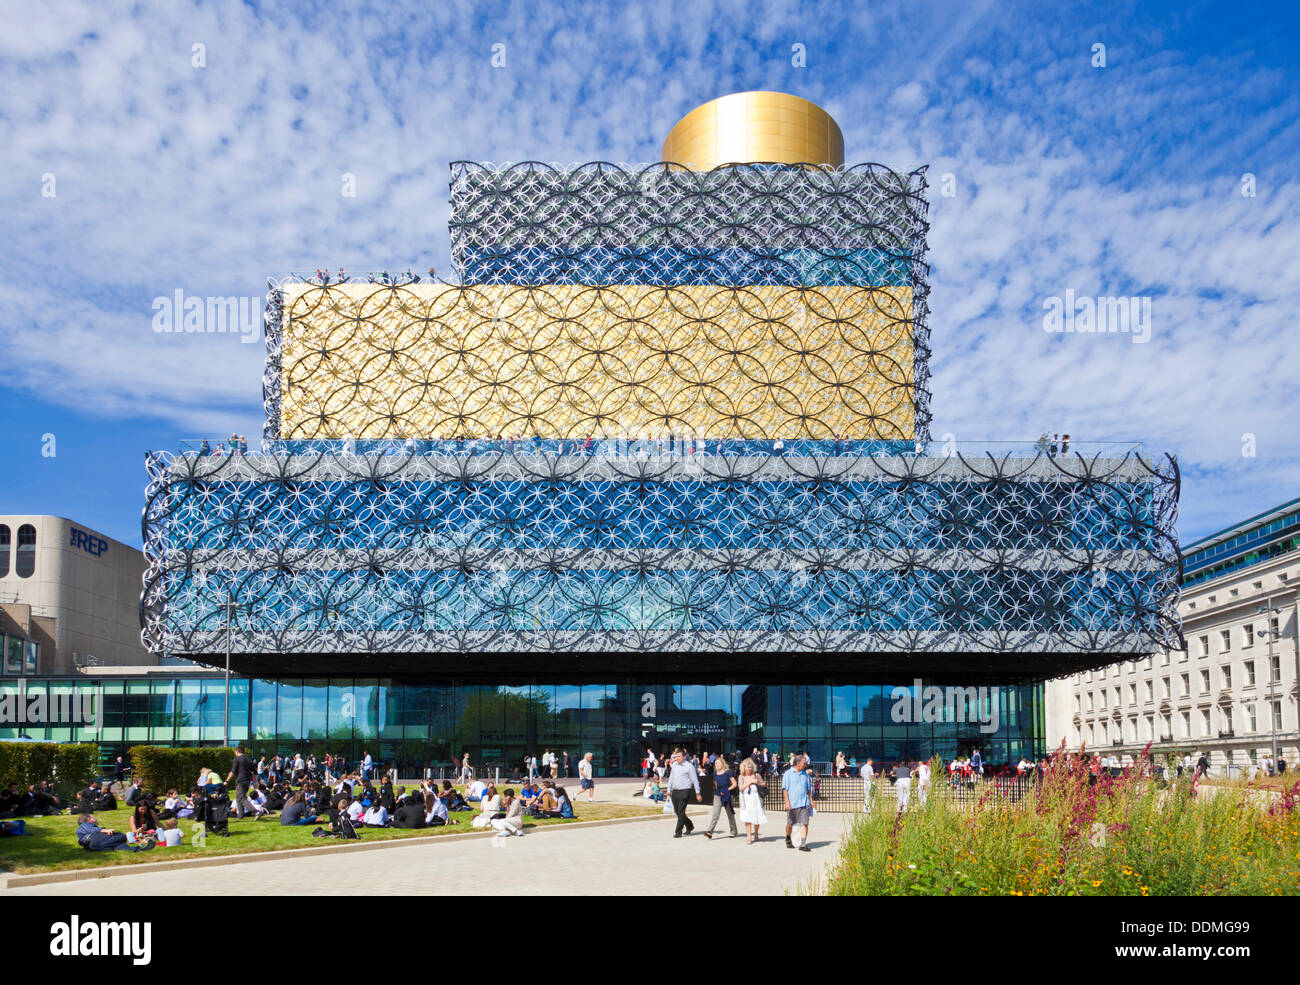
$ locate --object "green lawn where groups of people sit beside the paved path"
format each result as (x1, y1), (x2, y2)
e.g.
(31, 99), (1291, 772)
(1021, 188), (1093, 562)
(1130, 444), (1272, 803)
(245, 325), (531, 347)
(0, 803), (660, 873)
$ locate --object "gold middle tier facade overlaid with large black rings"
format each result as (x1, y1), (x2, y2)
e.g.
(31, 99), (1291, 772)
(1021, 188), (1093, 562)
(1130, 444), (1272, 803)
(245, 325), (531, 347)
(281, 283), (915, 441)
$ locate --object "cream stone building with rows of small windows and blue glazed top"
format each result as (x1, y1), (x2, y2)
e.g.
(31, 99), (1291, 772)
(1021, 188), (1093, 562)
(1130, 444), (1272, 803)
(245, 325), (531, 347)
(1047, 499), (1300, 774)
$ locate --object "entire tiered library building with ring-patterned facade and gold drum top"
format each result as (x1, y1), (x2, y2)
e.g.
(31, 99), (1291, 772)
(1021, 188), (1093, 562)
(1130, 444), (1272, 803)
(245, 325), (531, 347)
(2, 92), (1179, 774)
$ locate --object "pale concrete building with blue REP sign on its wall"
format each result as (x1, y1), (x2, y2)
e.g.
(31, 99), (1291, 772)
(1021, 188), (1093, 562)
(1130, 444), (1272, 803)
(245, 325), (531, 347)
(0, 516), (157, 677)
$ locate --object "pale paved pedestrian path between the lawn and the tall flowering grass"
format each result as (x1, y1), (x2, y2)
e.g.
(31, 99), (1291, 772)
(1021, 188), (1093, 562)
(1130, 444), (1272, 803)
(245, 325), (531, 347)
(0, 812), (850, 899)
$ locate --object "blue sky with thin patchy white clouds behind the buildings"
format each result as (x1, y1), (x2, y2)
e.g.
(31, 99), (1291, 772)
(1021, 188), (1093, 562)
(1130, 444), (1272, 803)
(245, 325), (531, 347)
(0, 0), (1300, 544)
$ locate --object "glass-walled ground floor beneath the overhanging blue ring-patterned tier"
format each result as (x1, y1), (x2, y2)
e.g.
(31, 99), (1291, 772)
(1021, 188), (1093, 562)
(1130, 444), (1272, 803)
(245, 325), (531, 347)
(0, 672), (1044, 776)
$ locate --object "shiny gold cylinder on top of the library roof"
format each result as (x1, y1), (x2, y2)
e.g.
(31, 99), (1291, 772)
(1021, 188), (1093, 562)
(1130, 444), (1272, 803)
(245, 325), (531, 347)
(660, 92), (844, 170)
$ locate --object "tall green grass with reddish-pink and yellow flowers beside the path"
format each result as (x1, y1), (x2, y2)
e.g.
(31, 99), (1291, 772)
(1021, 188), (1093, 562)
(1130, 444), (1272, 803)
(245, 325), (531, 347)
(826, 754), (1300, 897)
